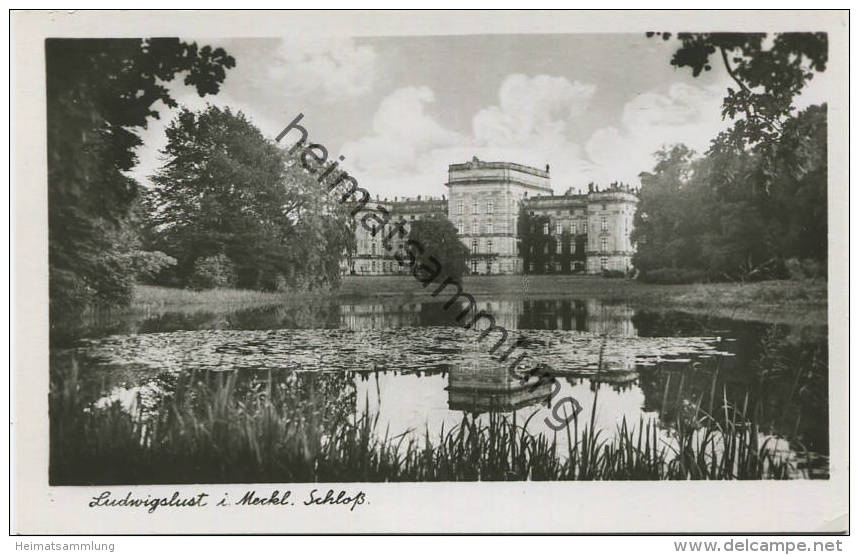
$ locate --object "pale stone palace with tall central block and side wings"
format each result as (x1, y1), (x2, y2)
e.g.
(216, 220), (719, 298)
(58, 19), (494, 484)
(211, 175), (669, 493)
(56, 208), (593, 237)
(344, 157), (638, 275)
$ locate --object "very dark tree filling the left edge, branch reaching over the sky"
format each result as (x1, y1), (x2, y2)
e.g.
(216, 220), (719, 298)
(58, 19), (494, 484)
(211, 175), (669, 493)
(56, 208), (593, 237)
(45, 39), (235, 315)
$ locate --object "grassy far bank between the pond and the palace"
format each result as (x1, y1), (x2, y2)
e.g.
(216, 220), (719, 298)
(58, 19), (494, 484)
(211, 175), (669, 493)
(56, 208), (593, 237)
(130, 275), (827, 325)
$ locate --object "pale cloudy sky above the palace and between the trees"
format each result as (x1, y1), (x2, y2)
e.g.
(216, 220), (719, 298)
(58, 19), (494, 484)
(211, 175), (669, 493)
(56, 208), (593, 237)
(133, 34), (829, 198)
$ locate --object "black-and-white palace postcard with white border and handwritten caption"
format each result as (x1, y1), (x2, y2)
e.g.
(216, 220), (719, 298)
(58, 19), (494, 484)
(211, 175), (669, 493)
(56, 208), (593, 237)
(12, 11), (849, 533)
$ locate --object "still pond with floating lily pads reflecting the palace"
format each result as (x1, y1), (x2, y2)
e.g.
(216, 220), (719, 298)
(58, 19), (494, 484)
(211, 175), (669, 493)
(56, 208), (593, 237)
(52, 298), (829, 478)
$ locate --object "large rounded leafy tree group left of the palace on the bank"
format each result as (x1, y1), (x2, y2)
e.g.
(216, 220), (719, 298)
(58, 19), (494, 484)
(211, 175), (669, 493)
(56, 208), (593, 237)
(148, 106), (354, 290)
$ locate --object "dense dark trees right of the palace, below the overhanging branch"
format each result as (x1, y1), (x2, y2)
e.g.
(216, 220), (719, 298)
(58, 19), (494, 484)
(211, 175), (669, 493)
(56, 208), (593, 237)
(632, 104), (827, 280)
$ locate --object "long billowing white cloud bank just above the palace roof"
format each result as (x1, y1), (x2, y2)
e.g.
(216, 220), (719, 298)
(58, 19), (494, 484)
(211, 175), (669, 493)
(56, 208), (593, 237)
(336, 74), (725, 197)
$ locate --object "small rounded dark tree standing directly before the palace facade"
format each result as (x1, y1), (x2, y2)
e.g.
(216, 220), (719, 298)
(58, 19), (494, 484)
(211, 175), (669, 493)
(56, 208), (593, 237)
(409, 218), (468, 279)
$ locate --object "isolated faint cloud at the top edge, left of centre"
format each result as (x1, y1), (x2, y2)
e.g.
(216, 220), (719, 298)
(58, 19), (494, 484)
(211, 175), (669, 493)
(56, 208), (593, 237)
(268, 39), (378, 102)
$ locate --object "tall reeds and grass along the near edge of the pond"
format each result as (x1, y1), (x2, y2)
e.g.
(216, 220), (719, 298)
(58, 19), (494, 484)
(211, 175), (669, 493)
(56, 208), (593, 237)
(50, 364), (790, 485)
